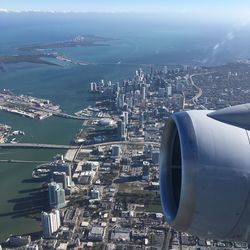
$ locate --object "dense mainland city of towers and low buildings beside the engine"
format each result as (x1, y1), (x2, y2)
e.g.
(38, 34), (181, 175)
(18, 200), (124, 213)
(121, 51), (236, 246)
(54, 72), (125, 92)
(2, 63), (248, 250)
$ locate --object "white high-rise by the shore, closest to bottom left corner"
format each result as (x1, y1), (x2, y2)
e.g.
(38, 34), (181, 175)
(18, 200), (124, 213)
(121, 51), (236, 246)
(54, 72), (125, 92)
(41, 210), (61, 238)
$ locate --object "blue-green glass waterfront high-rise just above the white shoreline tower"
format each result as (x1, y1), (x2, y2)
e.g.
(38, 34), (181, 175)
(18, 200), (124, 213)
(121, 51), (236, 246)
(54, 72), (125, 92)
(48, 182), (65, 208)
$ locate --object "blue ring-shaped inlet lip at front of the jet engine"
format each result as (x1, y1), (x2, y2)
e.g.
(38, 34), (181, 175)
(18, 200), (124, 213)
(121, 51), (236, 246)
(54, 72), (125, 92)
(160, 112), (198, 231)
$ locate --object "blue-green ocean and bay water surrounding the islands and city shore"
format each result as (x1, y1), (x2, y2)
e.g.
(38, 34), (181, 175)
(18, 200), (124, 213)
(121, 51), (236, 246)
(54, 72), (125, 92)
(0, 13), (250, 242)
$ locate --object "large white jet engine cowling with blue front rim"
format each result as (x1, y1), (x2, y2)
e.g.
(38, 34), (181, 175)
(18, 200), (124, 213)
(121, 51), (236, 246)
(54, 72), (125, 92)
(160, 111), (250, 241)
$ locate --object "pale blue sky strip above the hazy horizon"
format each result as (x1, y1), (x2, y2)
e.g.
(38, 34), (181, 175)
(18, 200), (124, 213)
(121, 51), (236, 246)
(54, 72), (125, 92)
(0, 0), (250, 19)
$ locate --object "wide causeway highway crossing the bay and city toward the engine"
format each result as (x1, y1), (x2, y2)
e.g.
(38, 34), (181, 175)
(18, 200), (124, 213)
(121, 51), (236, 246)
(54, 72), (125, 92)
(0, 141), (160, 149)
